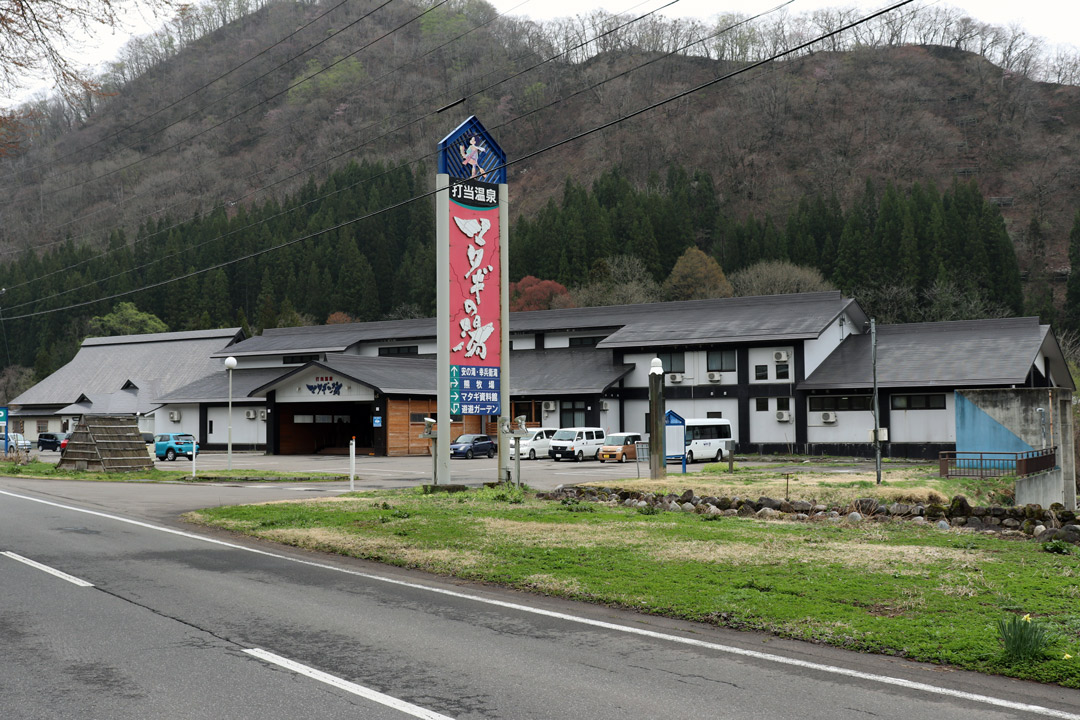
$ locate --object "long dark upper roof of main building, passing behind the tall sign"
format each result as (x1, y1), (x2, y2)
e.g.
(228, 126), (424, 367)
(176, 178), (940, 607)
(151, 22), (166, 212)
(215, 290), (867, 357)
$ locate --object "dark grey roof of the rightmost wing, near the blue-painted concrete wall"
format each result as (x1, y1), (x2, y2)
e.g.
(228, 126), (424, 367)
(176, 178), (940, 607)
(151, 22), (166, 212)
(799, 317), (1075, 390)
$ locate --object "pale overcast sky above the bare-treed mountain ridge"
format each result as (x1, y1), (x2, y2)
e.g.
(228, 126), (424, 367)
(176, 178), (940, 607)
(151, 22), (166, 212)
(6, 0), (1080, 105)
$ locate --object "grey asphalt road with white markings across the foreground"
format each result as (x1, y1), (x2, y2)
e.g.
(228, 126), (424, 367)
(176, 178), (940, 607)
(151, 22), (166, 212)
(0, 478), (1080, 720)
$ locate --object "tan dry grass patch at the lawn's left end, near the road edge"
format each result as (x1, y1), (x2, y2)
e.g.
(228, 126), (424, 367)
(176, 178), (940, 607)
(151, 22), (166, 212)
(256, 528), (484, 571)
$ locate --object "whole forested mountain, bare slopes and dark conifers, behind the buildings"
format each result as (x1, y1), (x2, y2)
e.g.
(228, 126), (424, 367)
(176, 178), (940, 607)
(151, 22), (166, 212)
(0, 0), (1080, 388)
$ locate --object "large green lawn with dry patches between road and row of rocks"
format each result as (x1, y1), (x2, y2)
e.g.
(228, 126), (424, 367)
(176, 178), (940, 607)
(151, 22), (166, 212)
(187, 481), (1080, 688)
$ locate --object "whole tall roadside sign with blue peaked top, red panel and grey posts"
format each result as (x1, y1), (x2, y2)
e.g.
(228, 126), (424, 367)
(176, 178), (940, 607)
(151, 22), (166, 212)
(435, 117), (510, 484)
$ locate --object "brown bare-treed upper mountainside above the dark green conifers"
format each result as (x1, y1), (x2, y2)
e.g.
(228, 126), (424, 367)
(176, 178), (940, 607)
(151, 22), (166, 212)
(0, 0), (1080, 332)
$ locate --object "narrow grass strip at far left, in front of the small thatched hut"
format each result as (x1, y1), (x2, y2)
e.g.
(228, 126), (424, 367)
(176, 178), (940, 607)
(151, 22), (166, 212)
(0, 459), (348, 483)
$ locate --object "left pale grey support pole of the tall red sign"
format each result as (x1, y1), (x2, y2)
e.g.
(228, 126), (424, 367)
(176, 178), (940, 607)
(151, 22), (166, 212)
(432, 173), (454, 485)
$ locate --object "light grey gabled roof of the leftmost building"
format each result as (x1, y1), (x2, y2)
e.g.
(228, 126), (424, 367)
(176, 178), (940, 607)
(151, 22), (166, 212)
(11, 327), (243, 413)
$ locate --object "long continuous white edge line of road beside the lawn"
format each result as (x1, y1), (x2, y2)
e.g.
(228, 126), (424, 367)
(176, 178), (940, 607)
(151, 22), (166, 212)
(0, 490), (1080, 720)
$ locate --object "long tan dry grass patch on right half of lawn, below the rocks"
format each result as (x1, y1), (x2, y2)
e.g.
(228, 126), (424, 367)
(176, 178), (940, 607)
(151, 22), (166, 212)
(653, 538), (990, 575)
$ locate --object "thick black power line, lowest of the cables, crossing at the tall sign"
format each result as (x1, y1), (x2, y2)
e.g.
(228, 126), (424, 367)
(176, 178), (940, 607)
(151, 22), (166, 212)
(0, 0), (915, 320)
